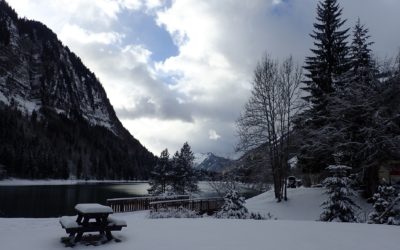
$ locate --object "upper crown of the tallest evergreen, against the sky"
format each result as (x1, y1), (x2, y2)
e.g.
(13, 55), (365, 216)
(305, 0), (349, 105)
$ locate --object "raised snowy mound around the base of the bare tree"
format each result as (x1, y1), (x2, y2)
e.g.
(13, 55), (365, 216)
(246, 188), (372, 220)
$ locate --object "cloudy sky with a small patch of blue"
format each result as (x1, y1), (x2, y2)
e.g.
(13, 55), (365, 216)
(8, 0), (400, 157)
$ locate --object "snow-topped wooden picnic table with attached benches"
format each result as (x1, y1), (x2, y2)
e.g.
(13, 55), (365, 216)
(60, 203), (127, 245)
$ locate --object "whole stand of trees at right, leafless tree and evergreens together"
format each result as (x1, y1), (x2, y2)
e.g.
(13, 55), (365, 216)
(237, 0), (400, 201)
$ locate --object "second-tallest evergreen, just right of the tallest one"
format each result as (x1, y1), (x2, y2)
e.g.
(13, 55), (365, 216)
(323, 19), (378, 168)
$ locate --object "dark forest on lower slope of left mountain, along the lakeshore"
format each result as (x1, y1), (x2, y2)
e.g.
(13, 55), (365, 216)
(0, 103), (155, 179)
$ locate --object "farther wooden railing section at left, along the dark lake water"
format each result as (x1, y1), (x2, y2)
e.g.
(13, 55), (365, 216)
(107, 195), (189, 213)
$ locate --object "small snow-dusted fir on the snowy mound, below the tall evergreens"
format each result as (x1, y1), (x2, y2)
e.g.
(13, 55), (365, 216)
(320, 165), (358, 222)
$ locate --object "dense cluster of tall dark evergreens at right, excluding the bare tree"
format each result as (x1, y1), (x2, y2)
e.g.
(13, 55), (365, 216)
(295, 0), (400, 196)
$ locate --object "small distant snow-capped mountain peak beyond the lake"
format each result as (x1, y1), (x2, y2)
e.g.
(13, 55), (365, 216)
(194, 153), (231, 173)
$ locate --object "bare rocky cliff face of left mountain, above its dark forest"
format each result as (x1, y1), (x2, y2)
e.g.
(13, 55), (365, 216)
(0, 0), (123, 134)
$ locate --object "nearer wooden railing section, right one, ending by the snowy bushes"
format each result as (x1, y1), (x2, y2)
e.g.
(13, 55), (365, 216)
(150, 197), (224, 214)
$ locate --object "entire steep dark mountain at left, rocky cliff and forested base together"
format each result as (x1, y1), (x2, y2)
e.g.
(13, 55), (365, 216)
(0, 0), (155, 179)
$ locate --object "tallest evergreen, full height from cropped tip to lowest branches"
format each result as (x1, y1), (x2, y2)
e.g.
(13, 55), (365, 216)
(296, 0), (350, 175)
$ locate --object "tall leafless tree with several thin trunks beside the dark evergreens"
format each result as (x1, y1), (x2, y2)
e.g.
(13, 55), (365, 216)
(237, 55), (302, 202)
